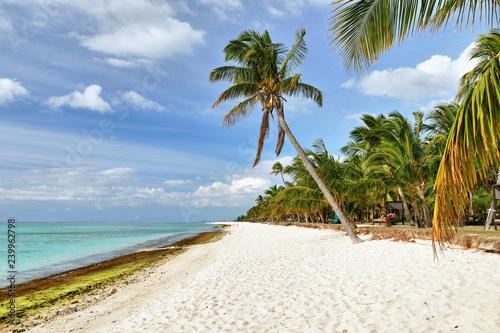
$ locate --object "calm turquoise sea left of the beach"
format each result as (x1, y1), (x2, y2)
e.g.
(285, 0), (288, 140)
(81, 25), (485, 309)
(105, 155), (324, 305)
(0, 222), (217, 288)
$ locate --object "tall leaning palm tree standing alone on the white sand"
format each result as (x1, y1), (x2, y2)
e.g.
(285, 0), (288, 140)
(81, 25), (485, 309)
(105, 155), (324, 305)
(210, 29), (361, 243)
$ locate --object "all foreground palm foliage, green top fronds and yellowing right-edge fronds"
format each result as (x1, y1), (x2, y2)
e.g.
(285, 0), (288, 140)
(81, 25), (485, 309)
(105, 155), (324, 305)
(329, 0), (500, 244)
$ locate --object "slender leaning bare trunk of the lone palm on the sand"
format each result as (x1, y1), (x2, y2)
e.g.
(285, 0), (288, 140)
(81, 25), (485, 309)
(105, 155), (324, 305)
(276, 110), (363, 244)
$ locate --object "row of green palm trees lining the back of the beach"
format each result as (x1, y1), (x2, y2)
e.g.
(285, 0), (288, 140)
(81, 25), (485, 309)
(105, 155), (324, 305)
(238, 103), (495, 228)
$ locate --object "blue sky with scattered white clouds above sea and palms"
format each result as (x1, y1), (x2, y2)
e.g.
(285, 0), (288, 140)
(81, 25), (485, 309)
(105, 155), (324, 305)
(0, 0), (485, 222)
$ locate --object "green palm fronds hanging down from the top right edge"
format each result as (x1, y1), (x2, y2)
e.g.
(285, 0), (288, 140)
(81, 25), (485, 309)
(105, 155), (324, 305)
(329, 0), (500, 72)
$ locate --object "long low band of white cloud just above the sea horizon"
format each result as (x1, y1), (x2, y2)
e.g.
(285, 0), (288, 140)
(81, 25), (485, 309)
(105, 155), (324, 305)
(0, 156), (292, 209)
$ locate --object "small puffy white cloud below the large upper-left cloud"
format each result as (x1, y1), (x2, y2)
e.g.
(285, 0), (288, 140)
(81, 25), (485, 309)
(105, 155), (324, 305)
(45, 84), (113, 113)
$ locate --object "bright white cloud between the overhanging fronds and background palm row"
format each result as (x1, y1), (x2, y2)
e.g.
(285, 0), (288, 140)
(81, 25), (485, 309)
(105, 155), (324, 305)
(341, 44), (474, 101)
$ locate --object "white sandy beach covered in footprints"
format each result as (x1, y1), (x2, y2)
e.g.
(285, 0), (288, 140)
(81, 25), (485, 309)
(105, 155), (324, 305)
(29, 223), (500, 333)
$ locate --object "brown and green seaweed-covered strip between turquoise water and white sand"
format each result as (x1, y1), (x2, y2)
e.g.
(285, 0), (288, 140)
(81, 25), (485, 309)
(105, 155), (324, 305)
(0, 224), (224, 332)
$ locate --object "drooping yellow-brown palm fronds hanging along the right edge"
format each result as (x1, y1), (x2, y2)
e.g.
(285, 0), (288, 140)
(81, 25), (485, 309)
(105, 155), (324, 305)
(434, 31), (500, 243)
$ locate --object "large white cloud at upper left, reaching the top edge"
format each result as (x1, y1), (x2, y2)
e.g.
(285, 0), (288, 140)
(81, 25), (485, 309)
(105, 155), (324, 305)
(0, 0), (205, 60)
